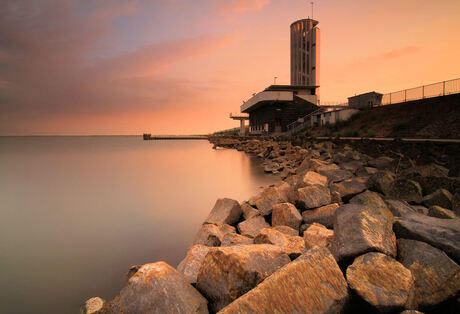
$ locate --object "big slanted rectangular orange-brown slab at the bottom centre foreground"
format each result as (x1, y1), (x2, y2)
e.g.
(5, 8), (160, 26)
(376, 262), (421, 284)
(219, 247), (349, 314)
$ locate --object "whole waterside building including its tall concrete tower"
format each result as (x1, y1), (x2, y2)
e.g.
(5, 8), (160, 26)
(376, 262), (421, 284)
(231, 19), (320, 135)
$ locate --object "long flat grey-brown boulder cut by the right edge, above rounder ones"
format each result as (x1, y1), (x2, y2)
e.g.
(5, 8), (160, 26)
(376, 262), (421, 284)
(393, 213), (460, 264)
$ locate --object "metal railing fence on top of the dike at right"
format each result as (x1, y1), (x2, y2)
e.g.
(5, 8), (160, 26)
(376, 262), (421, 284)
(382, 78), (460, 105)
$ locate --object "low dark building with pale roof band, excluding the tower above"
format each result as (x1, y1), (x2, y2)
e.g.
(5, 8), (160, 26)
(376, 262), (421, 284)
(241, 85), (318, 134)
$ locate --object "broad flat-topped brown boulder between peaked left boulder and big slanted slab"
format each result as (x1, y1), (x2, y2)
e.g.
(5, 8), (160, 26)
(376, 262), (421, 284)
(196, 245), (290, 312)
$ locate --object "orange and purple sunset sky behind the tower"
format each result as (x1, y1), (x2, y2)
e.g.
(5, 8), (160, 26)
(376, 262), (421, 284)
(0, 0), (460, 135)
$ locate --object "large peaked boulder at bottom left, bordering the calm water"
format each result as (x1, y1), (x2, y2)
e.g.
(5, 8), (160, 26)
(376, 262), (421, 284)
(109, 262), (208, 314)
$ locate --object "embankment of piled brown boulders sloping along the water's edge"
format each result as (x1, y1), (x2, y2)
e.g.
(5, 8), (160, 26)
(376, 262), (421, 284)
(83, 138), (460, 313)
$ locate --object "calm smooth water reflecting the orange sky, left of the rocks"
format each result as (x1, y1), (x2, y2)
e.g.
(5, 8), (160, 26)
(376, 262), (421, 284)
(0, 137), (276, 313)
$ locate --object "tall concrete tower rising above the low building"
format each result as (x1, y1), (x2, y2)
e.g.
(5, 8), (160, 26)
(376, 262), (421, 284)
(291, 19), (320, 86)
